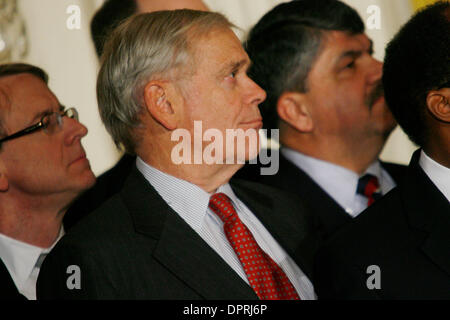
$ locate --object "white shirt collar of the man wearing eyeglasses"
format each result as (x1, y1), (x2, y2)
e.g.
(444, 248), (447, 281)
(0, 227), (65, 289)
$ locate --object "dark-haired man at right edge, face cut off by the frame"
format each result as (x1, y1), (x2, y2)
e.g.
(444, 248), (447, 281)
(315, 1), (450, 300)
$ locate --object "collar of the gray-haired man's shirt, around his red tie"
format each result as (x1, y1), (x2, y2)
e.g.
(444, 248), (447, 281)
(136, 157), (239, 232)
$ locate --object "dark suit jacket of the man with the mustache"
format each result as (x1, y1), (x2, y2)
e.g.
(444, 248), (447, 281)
(237, 154), (406, 241)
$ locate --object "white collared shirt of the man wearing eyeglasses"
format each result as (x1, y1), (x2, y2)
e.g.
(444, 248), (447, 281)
(0, 227), (64, 300)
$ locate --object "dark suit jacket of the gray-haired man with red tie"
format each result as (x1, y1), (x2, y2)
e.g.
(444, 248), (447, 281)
(37, 168), (314, 299)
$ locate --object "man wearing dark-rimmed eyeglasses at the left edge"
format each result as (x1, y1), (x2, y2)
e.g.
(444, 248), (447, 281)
(0, 64), (95, 299)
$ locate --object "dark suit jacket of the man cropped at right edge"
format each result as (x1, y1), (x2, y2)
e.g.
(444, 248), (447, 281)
(315, 152), (450, 299)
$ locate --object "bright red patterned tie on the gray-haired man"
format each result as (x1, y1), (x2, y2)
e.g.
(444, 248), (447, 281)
(209, 193), (300, 300)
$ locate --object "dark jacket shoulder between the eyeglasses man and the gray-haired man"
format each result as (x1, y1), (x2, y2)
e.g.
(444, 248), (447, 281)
(64, 154), (136, 229)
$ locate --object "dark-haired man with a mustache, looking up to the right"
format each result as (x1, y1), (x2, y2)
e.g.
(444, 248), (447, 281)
(238, 0), (403, 238)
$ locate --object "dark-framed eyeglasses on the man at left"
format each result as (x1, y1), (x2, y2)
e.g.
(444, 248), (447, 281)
(0, 108), (78, 143)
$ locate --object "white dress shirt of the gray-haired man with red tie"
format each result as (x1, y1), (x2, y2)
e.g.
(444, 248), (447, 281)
(136, 157), (316, 300)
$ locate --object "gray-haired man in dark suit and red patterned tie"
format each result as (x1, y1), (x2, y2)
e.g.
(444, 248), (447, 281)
(38, 10), (315, 299)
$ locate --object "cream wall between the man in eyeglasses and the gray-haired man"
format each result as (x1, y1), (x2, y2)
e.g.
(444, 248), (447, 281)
(19, 0), (118, 174)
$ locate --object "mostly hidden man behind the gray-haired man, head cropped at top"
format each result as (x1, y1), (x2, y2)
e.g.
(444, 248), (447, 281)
(64, 0), (208, 230)
